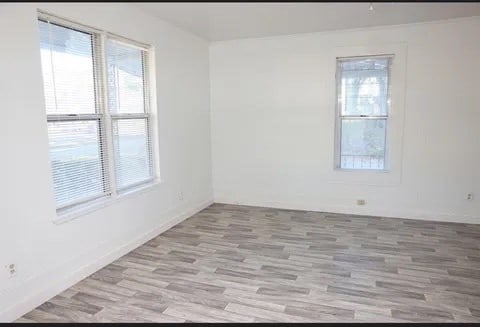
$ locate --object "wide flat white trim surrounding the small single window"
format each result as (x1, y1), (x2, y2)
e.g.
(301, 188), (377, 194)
(328, 43), (407, 186)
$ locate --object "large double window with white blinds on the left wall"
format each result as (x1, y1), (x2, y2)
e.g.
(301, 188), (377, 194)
(38, 14), (155, 212)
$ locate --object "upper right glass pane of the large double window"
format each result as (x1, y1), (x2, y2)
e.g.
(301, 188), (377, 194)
(107, 40), (145, 113)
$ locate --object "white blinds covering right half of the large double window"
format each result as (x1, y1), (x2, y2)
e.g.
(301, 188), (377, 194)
(106, 39), (153, 190)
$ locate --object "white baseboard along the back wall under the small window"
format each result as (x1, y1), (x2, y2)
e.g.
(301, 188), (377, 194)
(214, 195), (480, 224)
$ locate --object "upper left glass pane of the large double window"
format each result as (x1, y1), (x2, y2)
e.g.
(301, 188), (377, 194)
(38, 21), (95, 114)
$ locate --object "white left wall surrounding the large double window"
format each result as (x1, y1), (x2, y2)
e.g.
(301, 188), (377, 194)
(0, 3), (213, 321)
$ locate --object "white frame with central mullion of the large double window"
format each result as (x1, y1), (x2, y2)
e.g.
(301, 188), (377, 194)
(37, 10), (161, 224)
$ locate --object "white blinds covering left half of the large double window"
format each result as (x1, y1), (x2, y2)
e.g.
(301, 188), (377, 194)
(39, 20), (109, 209)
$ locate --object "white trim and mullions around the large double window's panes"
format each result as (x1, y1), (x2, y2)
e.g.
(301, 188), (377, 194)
(37, 10), (162, 224)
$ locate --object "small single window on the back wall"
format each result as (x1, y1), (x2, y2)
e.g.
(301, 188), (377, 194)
(335, 56), (392, 170)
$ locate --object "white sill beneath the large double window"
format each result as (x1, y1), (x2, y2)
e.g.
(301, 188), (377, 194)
(53, 180), (161, 225)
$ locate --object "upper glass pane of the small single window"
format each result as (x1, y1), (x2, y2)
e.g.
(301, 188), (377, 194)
(339, 58), (390, 116)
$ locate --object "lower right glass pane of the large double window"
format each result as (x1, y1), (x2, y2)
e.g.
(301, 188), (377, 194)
(113, 118), (152, 188)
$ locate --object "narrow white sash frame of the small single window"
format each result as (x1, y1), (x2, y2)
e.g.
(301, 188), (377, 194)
(335, 54), (395, 172)
